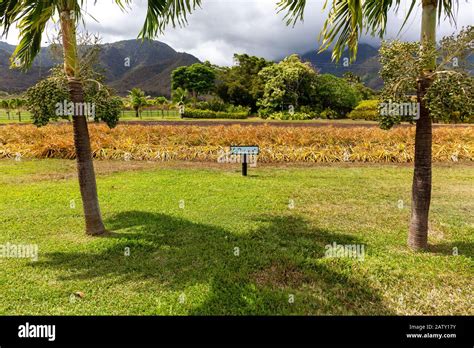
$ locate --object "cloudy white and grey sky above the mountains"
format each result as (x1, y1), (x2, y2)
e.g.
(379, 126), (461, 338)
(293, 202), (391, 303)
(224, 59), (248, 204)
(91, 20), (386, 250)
(3, 0), (474, 65)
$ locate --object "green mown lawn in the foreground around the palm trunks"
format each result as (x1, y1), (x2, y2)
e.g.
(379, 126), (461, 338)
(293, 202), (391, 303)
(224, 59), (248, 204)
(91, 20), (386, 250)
(0, 160), (474, 315)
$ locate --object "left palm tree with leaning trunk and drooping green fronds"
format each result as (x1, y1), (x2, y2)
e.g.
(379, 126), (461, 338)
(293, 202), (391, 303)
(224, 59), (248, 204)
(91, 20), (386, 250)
(0, 0), (200, 235)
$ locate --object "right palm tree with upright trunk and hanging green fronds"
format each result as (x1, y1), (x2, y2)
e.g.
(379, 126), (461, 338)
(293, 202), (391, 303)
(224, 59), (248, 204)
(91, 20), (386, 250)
(279, 0), (458, 250)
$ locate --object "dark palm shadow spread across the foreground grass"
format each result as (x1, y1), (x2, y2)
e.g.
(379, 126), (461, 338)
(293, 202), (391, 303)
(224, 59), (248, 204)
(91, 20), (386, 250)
(33, 211), (391, 315)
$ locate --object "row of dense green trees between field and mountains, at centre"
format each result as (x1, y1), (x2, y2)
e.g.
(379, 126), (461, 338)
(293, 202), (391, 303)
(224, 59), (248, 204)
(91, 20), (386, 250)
(171, 54), (376, 118)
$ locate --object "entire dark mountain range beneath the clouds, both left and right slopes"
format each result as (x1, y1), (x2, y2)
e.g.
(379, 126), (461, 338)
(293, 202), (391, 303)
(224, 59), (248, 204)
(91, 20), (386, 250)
(0, 40), (382, 96)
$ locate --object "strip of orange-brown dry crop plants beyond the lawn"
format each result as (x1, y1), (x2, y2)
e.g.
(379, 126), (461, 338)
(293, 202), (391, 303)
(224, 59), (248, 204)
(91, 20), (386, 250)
(0, 124), (474, 163)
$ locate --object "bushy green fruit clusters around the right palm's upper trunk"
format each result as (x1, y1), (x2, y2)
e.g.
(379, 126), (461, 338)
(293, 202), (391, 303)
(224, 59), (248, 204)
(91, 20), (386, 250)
(379, 26), (474, 129)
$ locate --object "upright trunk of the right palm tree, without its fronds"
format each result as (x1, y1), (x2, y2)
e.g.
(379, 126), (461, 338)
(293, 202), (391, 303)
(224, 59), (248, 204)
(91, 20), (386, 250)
(408, 0), (437, 250)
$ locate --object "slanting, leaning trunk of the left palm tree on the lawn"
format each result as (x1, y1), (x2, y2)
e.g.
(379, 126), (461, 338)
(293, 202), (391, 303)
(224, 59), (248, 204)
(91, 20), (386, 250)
(61, 10), (105, 235)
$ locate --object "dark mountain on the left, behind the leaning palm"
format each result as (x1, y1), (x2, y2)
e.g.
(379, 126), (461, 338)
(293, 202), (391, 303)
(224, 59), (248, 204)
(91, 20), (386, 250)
(0, 40), (199, 96)
